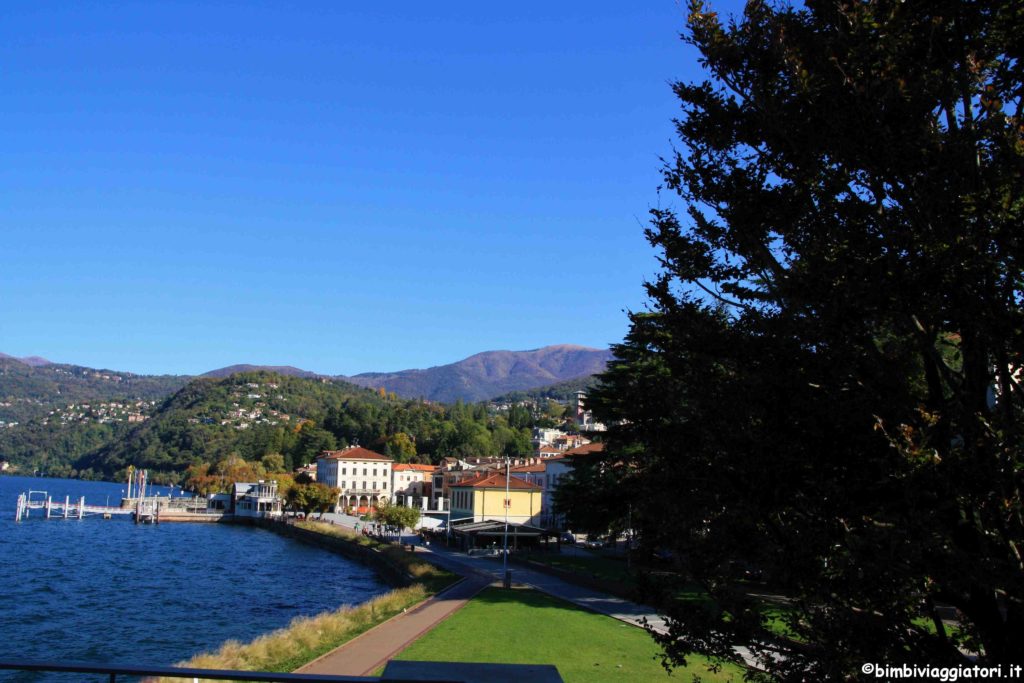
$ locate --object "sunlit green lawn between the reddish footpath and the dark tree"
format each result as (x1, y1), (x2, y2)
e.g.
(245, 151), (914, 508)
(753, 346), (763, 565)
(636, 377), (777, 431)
(395, 588), (742, 683)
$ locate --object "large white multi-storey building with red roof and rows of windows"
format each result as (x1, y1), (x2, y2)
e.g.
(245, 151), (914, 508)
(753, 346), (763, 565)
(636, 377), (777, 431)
(316, 445), (394, 512)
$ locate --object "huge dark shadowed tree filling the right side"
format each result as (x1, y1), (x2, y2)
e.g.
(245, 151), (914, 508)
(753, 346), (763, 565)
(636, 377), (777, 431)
(588, 0), (1024, 680)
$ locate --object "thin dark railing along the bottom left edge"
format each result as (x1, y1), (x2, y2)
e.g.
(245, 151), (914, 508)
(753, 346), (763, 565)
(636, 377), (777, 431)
(0, 659), (463, 683)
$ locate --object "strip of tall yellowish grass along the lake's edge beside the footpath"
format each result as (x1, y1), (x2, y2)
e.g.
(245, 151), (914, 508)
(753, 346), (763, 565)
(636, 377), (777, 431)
(152, 522), (457, 682)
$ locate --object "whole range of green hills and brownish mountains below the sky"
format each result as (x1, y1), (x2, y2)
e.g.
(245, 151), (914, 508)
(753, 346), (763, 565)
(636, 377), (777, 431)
(0, 345), (610, 481)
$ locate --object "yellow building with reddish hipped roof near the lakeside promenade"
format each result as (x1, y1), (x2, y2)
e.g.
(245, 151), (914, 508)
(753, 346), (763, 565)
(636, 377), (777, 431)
(451, 472), (543, 526)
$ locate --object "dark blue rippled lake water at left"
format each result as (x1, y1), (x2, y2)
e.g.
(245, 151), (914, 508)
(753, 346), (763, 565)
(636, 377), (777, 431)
(0, 476), (388, 682)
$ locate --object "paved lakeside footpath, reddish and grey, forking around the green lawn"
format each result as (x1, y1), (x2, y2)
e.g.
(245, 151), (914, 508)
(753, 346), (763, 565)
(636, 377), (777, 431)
(296, 514), (668, 676)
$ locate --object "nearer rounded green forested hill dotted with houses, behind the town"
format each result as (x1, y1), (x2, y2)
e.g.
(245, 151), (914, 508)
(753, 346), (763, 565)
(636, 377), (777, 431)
(74, 372), (532, 482)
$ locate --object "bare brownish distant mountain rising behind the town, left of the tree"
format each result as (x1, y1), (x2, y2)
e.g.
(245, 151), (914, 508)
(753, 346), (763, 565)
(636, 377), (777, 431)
(344, 344), (611, 402)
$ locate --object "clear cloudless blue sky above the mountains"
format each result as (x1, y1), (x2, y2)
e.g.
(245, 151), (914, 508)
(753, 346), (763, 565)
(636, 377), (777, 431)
(0, 0), (737, 374)
